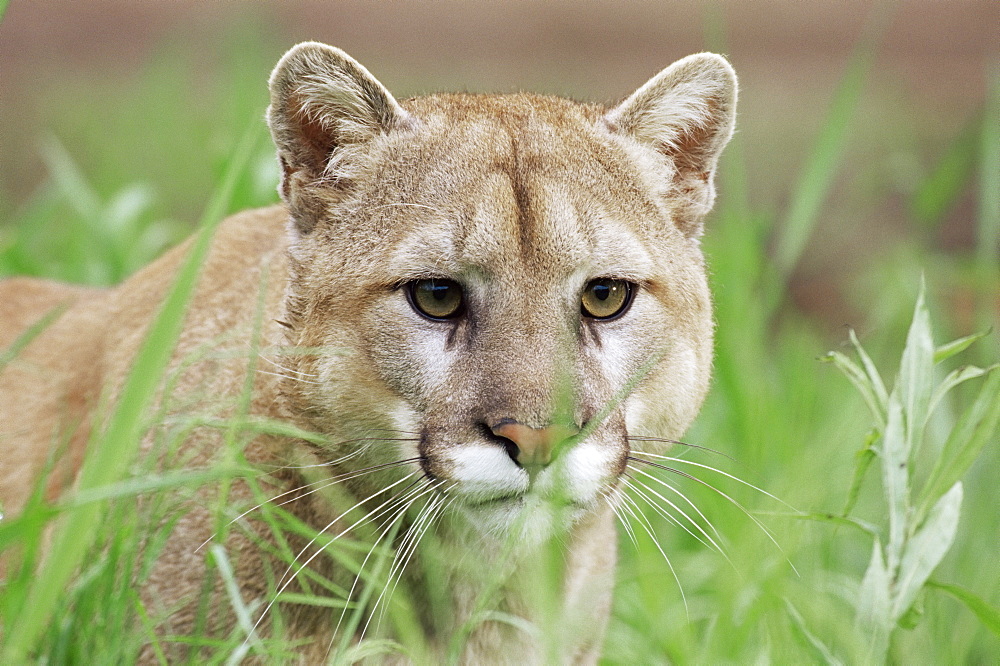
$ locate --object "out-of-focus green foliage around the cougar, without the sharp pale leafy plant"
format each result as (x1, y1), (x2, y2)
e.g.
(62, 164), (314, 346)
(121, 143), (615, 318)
(0, 19), (1000, 664)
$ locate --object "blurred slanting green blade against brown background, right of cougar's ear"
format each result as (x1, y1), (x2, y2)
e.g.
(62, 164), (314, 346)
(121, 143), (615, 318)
(775, 32), (875, 277)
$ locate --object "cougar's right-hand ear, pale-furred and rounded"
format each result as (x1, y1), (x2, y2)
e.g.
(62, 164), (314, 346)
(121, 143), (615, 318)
(605, 53), (737, 235)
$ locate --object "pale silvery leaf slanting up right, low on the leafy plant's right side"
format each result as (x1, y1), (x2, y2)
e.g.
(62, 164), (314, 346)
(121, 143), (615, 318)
(892, 481), (962, 621)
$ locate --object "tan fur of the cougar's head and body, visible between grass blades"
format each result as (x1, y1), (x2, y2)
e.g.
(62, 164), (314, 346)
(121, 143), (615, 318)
(0, 44), (736, 663)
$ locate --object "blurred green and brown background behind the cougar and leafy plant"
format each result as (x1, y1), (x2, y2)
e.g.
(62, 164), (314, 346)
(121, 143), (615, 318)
(0, 0), (1000, 663)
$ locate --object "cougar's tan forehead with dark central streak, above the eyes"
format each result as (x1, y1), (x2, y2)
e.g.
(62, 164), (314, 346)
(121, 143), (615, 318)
(376, 95), (657, 280)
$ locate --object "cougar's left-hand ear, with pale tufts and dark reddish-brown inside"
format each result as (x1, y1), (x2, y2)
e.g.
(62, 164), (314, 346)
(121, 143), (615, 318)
(267, 42), (410, 233)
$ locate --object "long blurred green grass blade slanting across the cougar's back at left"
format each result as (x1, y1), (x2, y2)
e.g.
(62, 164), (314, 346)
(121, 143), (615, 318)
(0, 127), (259, 663)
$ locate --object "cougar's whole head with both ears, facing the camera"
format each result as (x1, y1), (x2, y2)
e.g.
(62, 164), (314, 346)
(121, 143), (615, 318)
(269, 45), (735, 527)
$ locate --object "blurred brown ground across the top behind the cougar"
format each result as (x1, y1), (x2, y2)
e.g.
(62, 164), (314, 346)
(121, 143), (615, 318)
(0, 0), (1000, 326)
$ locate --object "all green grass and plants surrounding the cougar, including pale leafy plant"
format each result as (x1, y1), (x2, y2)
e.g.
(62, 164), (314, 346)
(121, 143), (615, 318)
(0, 23), (1000, 664)
